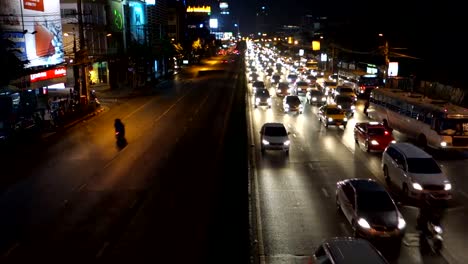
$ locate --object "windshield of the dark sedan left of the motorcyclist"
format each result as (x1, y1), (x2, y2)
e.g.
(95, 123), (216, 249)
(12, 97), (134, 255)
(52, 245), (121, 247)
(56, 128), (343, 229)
(356, 191), (395, 212)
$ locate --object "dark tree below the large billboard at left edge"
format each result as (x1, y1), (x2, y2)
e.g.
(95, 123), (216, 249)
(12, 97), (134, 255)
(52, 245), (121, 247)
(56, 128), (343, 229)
(0, 34), (29, 86)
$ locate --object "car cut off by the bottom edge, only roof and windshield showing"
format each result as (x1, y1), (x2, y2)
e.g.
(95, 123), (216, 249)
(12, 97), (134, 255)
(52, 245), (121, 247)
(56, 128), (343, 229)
(309, 237), (388, 264)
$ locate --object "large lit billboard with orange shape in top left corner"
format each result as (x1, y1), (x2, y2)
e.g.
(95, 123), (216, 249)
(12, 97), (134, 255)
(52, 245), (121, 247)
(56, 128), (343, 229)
(0, 0), (64, 67)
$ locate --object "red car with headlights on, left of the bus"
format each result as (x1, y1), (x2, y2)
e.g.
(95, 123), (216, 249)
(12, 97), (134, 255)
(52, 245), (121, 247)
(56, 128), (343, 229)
(354, 121), (396, 152)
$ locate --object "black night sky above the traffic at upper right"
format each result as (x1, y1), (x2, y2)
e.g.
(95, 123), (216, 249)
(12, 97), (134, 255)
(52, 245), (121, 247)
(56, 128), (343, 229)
(229, 0), (468, 89)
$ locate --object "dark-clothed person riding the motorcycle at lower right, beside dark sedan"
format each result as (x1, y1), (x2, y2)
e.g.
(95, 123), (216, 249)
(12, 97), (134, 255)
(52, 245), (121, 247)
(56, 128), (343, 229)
(417, 194), (447, 232)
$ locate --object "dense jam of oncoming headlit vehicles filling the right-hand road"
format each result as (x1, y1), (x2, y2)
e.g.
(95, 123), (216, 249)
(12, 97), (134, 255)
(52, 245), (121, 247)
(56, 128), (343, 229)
(245, 39), (468, 263)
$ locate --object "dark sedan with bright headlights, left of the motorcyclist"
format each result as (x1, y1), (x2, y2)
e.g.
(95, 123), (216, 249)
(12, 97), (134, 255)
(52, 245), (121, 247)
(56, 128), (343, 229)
(335, 178), (406, 242)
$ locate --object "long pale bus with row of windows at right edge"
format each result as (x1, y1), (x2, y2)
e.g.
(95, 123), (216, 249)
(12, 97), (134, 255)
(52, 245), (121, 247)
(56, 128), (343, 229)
(367, 88), (468, 150)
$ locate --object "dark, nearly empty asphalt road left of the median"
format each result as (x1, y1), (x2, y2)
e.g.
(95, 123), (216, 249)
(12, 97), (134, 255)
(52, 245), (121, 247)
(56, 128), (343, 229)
(0, 54), (249, 263)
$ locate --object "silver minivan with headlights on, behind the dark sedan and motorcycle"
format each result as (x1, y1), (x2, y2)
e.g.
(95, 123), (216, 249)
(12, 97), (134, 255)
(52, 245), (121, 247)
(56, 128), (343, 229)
(381, 142), (452, 200)
